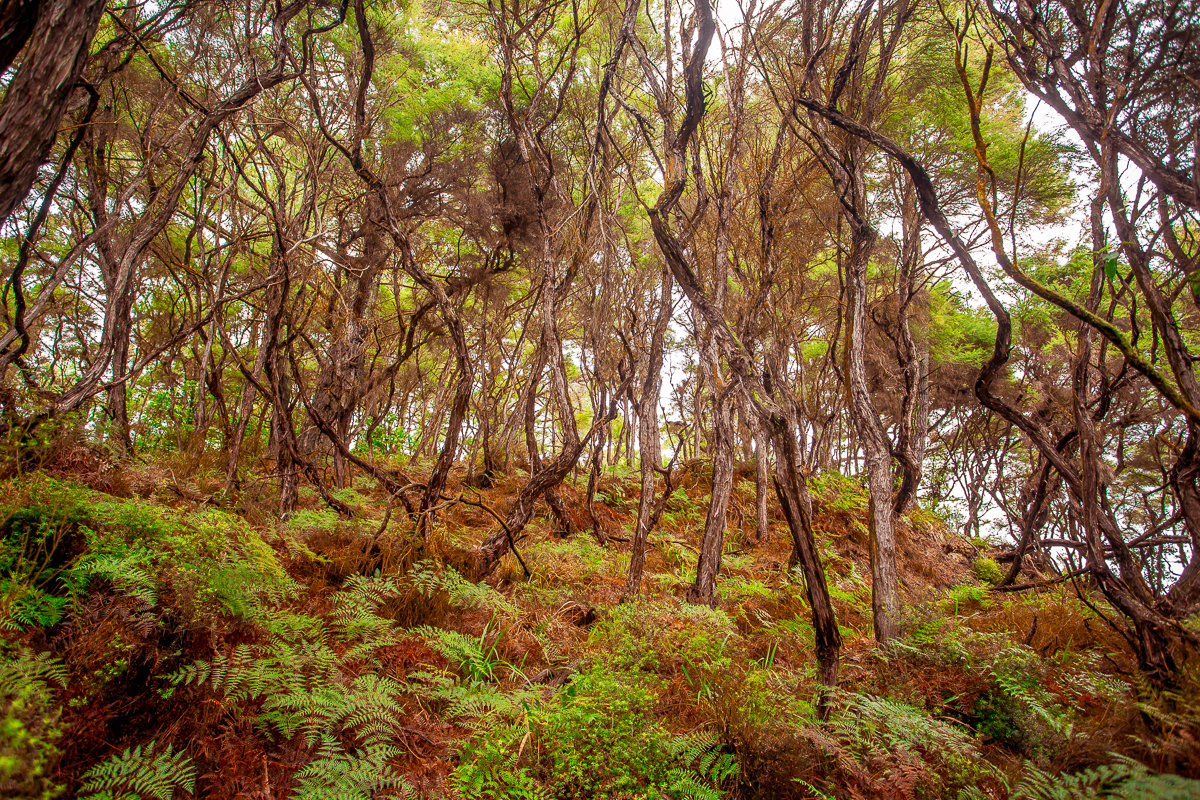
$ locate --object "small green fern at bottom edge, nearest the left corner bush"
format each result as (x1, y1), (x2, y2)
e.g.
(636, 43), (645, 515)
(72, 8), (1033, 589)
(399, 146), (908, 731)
(79, 741), (196, 800)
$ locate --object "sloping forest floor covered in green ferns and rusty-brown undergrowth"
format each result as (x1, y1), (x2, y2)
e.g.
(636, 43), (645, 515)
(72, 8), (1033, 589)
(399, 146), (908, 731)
(0, 446), (1200, 799)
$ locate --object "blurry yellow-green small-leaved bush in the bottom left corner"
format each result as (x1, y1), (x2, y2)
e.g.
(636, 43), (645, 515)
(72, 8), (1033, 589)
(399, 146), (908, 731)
(0, 648), (67, 800)
